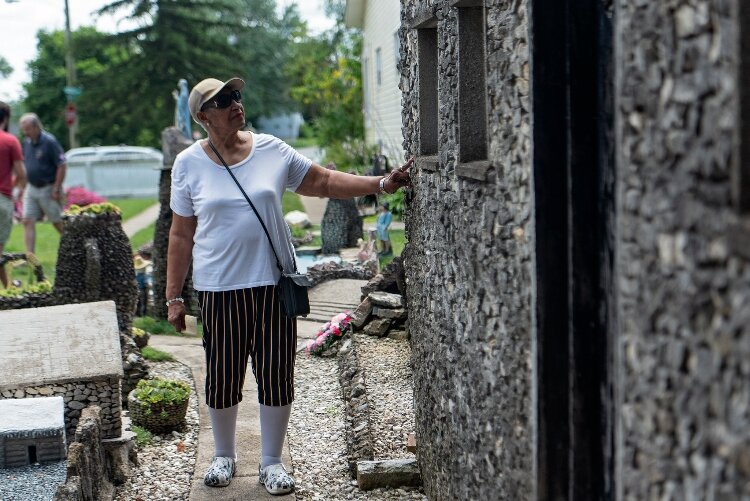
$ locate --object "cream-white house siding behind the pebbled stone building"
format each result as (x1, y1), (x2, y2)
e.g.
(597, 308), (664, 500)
(362, 0), (404, 166)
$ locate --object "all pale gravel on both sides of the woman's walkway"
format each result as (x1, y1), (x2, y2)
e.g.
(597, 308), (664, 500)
(109, 334), (427, 501)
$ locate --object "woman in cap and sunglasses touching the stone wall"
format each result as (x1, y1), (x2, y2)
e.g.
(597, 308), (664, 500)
(166, 78), (412, 494)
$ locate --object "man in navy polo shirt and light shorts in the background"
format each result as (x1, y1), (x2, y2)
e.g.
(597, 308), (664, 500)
(19, 113), (67, 254)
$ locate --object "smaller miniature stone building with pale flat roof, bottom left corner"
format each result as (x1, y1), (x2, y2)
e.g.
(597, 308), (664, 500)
(0, 397), (65, 468)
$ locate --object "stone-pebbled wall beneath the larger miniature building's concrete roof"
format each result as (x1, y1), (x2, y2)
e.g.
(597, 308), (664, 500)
(0, 378), (122, 441)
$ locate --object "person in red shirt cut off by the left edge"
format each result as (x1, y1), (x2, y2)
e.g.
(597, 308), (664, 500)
(0, 101), (26, 288)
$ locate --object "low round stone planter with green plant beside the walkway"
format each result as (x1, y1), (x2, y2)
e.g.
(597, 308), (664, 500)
(128, 378), (190, 433)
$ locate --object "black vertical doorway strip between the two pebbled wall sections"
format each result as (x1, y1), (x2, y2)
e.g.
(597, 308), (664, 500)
(531, 0), (616, 501)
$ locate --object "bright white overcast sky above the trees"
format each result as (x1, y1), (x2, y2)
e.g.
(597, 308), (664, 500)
(0, 0), (333, 101)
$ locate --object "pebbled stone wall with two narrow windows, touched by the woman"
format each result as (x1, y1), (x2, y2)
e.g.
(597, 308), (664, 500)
(400, 0), (536, 500)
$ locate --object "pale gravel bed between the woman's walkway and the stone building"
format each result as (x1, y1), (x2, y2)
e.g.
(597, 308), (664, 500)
(288, 335), (427, 501)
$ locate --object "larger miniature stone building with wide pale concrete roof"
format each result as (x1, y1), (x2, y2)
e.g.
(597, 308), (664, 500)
(0, 301), (123, 439)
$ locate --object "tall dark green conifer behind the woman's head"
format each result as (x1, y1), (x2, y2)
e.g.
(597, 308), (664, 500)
(93, 0), (243, 147)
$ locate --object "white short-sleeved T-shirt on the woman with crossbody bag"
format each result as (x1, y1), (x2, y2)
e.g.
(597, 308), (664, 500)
(169, 134), (312, 291)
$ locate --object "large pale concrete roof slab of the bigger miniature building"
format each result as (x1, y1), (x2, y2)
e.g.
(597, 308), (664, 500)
(0, 301), (123, 390)
